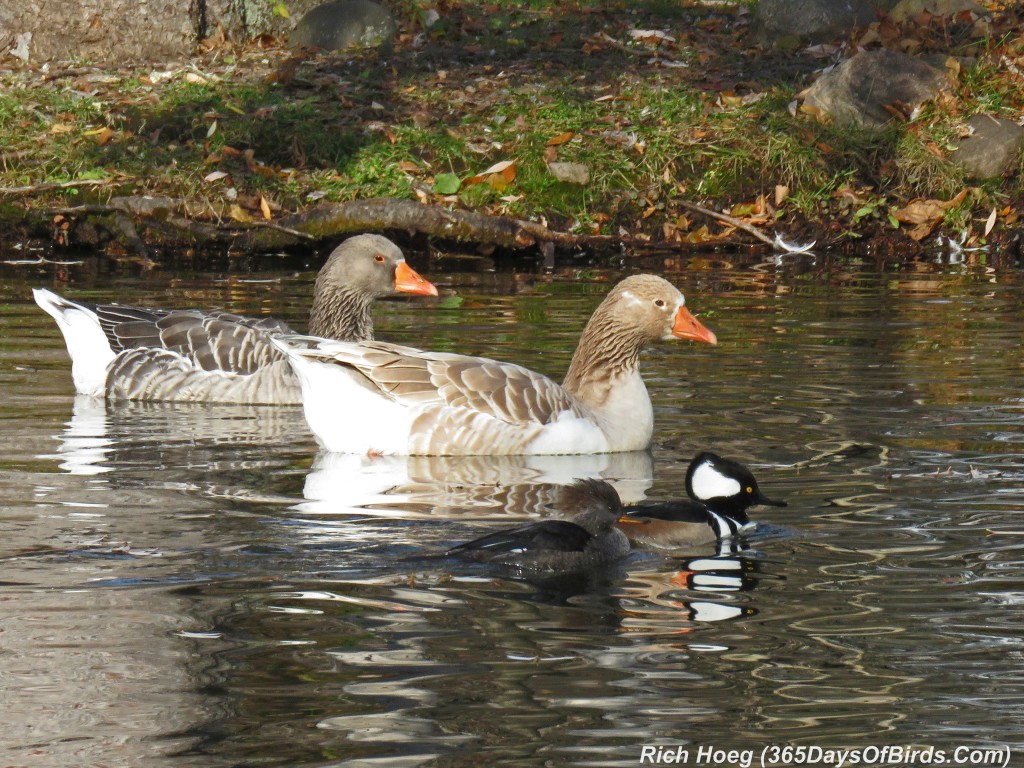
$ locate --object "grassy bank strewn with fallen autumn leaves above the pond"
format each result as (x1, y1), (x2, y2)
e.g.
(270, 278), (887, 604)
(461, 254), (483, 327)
(0, 1), (1024, 252)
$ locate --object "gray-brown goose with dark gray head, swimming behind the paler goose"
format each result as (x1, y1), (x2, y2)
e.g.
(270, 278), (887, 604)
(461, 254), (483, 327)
(33, 234), (437, 404)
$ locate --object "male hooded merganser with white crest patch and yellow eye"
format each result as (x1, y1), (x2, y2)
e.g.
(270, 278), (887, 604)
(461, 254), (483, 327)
(618, 451), (786, 548)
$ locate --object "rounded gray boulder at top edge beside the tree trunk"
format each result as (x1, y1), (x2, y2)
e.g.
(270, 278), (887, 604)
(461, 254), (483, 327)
(289, 0), (398, 50)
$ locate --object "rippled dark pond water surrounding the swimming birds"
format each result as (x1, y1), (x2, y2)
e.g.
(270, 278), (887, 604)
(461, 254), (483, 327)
(0, 247), (1024, 767)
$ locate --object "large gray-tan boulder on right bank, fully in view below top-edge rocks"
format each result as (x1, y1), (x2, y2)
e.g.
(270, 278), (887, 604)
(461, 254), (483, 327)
(804, 50), (949, 128)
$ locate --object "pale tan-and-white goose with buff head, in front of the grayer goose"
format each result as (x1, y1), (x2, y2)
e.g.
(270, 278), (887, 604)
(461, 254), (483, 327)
(273, 274), (717, 456)
